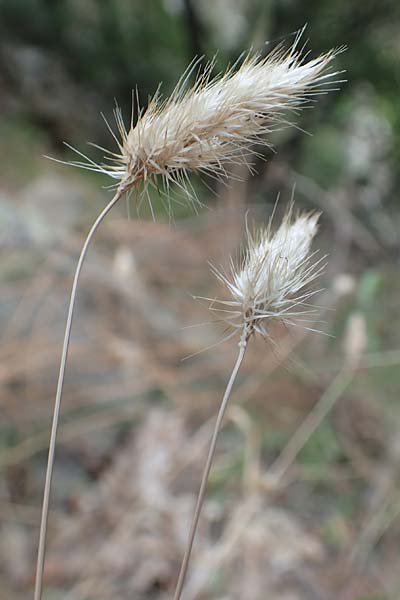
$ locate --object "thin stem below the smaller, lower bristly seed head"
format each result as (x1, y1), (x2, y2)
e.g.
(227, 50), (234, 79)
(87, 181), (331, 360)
(174, 339), (247, 600)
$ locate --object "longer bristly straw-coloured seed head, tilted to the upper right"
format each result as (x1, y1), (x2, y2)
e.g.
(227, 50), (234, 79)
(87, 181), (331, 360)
(67, 37), (337, 210)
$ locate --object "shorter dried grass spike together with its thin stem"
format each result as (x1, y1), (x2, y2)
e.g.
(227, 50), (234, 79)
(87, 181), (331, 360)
(174, 209), (322, 600)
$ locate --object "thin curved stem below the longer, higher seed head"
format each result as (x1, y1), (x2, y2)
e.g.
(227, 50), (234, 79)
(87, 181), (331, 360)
(34, 190), (122, 600)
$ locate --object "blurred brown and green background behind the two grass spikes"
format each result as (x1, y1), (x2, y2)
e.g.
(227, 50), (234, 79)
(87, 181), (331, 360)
(0, 0), (400, 600)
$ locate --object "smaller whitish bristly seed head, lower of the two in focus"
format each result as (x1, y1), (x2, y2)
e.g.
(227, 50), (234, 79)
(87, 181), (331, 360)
(210, 209), (323, 339)
